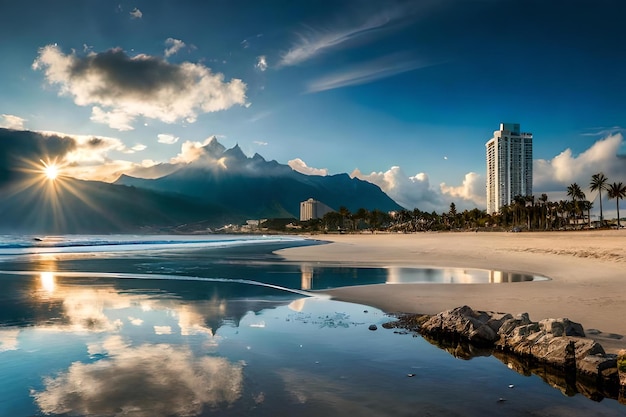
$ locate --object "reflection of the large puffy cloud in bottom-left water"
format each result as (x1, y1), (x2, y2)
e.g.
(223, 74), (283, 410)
(33, 337), (243, 417)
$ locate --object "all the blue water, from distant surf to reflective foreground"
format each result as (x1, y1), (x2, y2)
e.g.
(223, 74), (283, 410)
(0, 235), (626, 417)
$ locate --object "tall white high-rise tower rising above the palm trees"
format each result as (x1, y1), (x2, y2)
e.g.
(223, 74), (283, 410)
(485, 123), (533, 214)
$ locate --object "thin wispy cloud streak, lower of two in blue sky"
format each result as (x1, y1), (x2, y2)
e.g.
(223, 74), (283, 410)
(307, 54), (432, 93)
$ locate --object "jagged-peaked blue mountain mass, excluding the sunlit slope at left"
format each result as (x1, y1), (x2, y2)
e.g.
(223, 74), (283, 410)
(115, 138), (401, 219)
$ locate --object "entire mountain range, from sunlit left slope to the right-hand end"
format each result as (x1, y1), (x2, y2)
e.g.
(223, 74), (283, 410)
(0, 138), (401, 233)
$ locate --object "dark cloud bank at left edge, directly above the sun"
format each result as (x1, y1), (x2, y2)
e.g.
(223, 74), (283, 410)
(0, 128), (77, 183)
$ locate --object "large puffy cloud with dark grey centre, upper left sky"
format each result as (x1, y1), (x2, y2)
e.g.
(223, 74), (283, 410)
(33, 45), (246, 130)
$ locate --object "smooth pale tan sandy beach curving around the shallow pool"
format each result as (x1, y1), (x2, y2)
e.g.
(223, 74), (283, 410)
(278, 230), (626, 352)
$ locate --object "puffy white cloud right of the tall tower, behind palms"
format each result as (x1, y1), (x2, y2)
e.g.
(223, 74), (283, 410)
(533, 133), (626, 193)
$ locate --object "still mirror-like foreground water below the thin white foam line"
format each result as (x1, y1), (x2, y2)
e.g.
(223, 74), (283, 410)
(0, 268), (615, 417)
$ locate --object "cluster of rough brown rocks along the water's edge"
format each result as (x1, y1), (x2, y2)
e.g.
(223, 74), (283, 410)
(388, 306), (626, 401)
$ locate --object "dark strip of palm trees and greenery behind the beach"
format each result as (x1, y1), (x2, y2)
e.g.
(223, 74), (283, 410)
(299, 172), (626, 233)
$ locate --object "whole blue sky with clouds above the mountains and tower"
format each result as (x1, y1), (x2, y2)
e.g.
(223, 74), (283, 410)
(0, 0), (626, 211)
